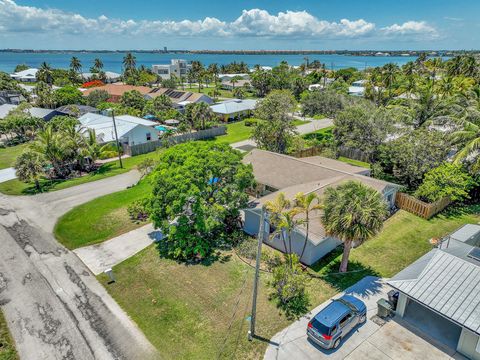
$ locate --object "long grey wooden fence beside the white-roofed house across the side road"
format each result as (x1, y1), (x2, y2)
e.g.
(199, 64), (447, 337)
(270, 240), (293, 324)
(123, 126), (227, 156)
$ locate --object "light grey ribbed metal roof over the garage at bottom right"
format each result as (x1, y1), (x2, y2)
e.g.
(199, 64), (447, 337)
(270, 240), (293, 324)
(388, 249), (480, 334)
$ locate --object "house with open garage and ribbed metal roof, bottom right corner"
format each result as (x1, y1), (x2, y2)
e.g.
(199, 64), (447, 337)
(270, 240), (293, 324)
(388, 224), (480, 360)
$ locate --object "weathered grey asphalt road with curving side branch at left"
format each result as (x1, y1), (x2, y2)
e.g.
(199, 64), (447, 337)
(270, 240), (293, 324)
(0, 172), (158, 360)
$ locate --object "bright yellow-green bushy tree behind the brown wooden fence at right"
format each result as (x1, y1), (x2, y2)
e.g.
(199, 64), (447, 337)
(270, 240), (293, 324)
(415, 163), (475, 202)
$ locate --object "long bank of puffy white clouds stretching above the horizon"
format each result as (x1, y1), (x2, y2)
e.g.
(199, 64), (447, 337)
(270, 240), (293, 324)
(0, 0), (436, 39)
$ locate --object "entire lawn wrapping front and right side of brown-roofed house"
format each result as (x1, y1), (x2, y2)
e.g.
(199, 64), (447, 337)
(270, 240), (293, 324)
(95, 206), (480, 359)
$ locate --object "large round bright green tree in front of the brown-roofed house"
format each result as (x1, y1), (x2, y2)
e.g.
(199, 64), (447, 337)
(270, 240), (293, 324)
(149, 142), (254, 260)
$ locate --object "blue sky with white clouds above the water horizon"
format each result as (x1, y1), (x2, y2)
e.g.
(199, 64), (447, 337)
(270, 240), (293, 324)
(0, 0), (480, 50)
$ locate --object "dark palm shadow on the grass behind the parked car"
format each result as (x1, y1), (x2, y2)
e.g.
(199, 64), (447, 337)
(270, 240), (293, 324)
(310, 247), (381, 292)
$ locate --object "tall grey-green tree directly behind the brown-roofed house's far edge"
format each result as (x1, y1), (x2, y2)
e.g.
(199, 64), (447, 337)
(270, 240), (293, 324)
(252, 90), (296, 154)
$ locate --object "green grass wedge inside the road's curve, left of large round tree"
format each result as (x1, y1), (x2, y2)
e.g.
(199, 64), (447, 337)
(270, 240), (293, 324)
(54, 180), (151, 249)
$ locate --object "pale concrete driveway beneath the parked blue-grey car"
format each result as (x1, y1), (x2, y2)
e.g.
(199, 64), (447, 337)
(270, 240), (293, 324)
(264, 276), (459, 360)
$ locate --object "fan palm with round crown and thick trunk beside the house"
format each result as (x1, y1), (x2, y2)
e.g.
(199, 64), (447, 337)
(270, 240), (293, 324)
(322, 181), (387, 272)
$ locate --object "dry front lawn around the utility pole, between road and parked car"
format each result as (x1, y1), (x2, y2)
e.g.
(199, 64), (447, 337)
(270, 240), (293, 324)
(98, 245), (335, 360)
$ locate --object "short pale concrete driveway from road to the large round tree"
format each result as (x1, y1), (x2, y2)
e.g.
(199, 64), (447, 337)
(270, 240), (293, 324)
(73, 224), (162, 275)
